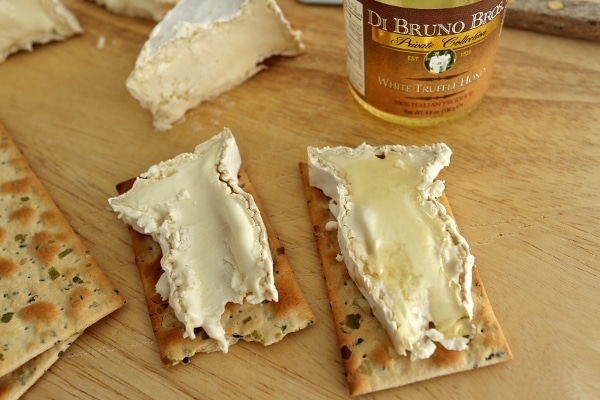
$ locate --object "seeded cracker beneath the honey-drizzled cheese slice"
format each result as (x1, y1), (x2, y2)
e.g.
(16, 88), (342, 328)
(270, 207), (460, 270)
(300, 162), (512, 396)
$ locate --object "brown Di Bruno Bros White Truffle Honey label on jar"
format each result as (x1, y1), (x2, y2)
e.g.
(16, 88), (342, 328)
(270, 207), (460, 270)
(344, 0), (506, 118)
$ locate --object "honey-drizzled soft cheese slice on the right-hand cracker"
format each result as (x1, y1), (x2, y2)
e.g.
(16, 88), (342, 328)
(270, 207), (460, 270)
(308, 144), (474, 360)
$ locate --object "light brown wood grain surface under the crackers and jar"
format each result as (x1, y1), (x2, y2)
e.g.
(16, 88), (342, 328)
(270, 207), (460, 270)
(0, 0), (600, 400)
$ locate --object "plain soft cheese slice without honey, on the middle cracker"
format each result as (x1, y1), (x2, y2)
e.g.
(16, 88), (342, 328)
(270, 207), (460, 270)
(108, 129), (278, 352)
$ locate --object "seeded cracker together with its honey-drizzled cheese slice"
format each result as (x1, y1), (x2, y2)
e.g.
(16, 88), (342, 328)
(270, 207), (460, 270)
(300, 144), (512, 395)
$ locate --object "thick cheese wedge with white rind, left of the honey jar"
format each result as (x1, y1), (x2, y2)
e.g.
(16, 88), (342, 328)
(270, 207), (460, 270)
(126, 0), (304, 131)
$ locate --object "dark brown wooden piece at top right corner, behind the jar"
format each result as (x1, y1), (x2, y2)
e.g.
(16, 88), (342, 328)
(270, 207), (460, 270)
(504, 0), (600, 41)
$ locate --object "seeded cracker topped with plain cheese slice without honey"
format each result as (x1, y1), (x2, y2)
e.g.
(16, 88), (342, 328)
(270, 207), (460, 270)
(109, 129), (315, 366)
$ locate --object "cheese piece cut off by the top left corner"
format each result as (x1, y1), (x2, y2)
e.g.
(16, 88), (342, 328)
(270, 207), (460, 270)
(0, 0), (83, 62)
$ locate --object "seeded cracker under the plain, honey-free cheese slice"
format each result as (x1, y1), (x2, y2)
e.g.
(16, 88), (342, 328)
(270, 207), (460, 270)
(117, 168), (315, 367)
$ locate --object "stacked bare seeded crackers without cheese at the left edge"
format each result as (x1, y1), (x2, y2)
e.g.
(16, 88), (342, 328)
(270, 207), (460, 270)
(0, 124), (125, 398)
